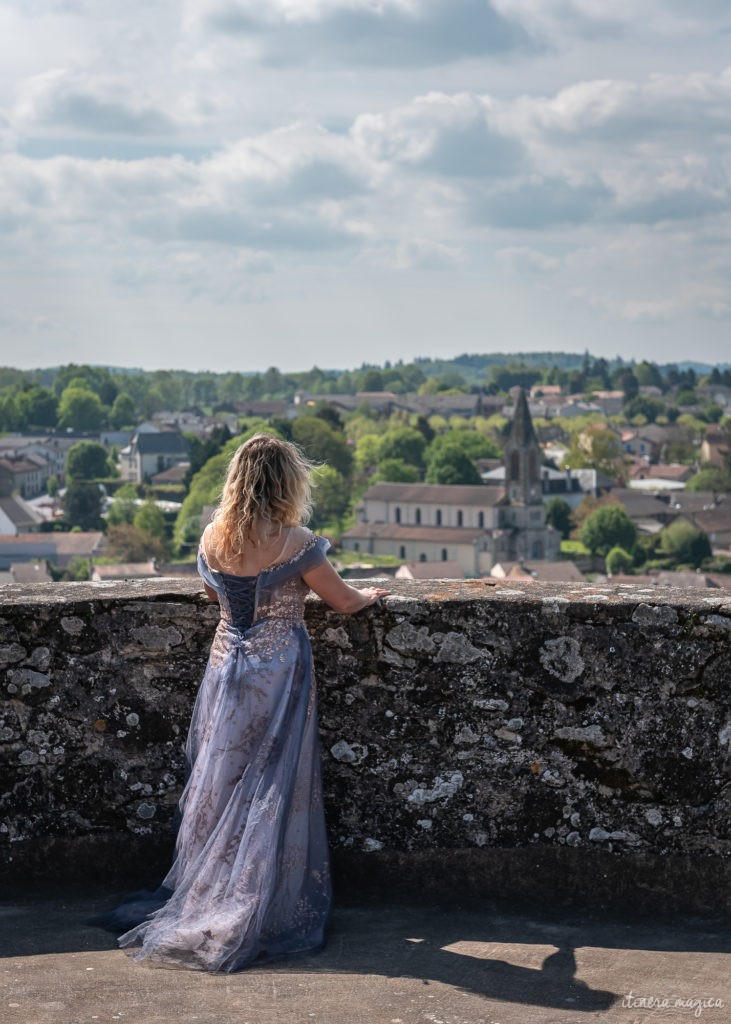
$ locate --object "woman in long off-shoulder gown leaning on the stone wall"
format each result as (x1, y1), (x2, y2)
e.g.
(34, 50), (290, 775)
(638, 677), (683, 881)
(109, 434), (388, 972)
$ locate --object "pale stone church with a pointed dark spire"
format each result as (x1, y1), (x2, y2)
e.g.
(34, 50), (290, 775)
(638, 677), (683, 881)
(342, 390), (561, 578)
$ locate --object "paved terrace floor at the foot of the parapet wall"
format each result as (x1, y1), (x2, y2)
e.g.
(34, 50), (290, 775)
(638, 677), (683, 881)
(0, 886), (731, 1024)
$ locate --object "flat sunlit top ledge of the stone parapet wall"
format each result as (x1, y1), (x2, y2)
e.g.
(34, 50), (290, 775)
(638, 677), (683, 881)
(0, 577), (731, 614)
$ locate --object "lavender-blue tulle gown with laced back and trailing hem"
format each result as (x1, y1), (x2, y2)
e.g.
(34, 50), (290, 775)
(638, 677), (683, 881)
(111, 534), (332, 972)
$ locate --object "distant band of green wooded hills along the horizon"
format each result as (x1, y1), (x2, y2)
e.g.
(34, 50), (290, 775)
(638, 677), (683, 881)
(0, 352), (731, 432)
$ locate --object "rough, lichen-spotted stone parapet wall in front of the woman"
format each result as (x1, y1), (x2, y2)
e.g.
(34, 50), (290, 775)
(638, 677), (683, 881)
(0, 579), (731, 909)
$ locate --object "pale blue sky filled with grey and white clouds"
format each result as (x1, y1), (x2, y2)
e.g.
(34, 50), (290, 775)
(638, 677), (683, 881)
(0, 0), (731, 372)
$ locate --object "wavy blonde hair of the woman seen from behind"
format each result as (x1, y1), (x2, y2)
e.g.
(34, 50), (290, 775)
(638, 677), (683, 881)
(212, 434), (313, 559)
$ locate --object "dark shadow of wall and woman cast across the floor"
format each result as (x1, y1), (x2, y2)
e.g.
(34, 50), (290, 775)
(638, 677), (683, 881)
(0, 887), (731, 1013)
